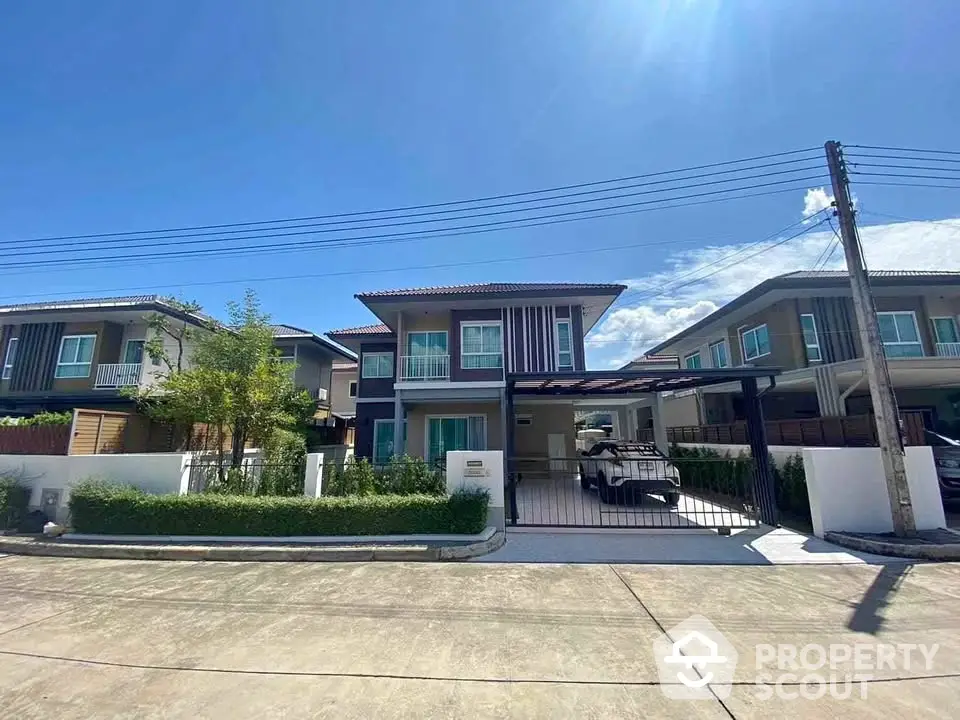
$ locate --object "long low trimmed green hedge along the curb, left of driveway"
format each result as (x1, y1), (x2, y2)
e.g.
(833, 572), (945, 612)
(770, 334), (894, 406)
(70, 481), (490, 536)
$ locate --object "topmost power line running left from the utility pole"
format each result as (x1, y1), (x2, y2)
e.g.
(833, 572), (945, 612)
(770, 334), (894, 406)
(5, 148), (820, 242)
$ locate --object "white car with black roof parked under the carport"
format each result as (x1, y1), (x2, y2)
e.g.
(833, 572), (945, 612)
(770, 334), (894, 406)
(580, 440), (680, 507)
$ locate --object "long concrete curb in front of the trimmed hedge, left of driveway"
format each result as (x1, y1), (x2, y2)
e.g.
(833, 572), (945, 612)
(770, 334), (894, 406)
(0, 531), (506, 562)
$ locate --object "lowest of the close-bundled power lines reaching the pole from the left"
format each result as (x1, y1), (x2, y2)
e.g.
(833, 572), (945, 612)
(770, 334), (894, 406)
(0, 176), (832, 268)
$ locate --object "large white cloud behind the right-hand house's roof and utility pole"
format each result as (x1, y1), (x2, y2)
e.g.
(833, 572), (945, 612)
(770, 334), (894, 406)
(587, 218), (960, 368)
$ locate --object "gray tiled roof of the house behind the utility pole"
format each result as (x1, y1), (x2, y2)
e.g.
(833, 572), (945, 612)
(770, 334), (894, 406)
(647, 270), (960, 355)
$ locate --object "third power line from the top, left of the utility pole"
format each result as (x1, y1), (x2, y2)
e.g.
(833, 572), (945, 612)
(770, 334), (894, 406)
(0, 166), (822, 257)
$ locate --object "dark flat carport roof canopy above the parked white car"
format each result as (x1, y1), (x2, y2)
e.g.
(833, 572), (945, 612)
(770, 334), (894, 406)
(507, 367), (780, 396)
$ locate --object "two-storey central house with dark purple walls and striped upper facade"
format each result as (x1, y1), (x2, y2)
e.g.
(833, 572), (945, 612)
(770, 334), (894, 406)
(328, 283), (625, 463)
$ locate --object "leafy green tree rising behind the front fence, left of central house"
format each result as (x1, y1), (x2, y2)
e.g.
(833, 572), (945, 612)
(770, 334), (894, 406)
(139, 291), (314, 468)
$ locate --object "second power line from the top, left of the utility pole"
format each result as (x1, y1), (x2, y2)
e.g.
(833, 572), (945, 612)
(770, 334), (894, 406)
(0, 158), (821, 248)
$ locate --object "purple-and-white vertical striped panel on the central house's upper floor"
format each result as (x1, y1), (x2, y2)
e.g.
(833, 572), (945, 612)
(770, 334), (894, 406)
(503, 305), (584, 373)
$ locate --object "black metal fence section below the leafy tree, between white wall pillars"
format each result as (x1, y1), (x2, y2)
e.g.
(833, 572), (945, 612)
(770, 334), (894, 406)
(188, 458), (306, 496)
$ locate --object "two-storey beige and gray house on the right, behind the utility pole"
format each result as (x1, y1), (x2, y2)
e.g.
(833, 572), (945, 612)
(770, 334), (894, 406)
(640, 271), (960, 434)
